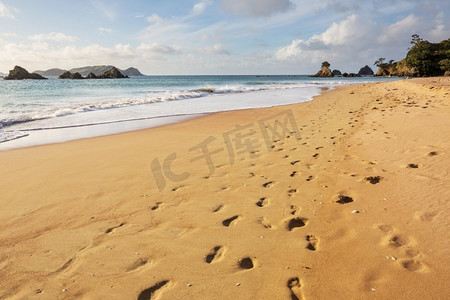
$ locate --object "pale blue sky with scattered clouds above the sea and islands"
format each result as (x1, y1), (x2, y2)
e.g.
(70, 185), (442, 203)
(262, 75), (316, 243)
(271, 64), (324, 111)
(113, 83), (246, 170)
(0, 0), (450, 75)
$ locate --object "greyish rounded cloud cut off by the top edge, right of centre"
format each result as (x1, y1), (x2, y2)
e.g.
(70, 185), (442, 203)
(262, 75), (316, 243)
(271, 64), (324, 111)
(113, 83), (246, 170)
(222, 0), (294, 17)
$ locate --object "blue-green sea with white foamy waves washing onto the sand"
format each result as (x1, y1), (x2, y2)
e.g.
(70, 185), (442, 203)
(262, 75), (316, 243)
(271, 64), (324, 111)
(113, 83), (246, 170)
(0, 75), (396, 150)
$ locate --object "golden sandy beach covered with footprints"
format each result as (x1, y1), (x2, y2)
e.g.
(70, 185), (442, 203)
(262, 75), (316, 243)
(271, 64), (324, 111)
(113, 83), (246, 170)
(0, 77), (450, 300)
